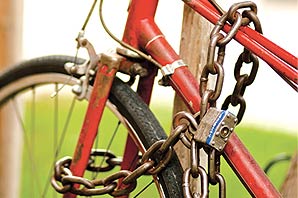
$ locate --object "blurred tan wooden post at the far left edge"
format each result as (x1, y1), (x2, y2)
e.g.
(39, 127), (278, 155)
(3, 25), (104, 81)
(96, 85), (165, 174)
(0, 0), (22, 198)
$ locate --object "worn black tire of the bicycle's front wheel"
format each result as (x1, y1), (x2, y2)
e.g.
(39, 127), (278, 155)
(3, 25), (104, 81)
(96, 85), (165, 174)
(0, 56), (183, 198)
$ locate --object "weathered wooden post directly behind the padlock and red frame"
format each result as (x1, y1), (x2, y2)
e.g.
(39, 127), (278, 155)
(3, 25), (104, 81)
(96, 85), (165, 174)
(173, 5), (212, 169)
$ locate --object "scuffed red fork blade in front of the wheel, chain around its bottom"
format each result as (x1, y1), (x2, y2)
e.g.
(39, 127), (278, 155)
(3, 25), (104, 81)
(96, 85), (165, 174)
(64, 54), (121, 198)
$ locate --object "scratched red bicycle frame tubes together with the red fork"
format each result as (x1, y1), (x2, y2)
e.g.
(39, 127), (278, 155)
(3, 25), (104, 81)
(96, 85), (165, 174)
(65, 0), (298, 197)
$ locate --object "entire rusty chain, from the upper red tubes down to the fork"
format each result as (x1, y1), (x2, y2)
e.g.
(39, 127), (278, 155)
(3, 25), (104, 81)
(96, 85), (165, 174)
(51, 2), (262, 198)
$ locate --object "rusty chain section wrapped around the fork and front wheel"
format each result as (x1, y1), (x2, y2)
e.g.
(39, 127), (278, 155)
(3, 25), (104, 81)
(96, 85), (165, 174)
(51, 112), (197, 196)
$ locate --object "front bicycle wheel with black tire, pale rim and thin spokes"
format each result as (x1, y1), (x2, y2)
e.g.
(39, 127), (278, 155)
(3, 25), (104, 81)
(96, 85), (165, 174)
(0, 56), (182, 198)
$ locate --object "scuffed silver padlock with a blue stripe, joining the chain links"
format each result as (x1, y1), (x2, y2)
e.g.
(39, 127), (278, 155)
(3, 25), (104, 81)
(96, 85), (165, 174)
(194, 107), (238, 151)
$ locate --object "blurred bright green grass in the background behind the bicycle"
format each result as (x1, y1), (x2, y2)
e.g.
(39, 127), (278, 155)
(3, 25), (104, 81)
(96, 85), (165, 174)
(22, 98), (297, 197)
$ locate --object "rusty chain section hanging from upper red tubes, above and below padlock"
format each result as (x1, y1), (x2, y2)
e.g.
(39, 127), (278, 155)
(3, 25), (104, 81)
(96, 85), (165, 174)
(192, 2), (262, 197)
